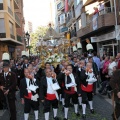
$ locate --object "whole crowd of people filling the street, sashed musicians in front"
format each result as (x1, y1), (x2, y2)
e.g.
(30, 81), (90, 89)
(0, 51), (120, 120)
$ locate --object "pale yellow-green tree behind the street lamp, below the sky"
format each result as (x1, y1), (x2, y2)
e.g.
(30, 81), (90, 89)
(30, 26), (48, 54)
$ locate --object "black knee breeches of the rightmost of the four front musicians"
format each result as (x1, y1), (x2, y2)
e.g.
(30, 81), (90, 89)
(81, 91), (93, 104)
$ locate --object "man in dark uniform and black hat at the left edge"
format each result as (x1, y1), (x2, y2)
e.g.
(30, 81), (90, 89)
(0, 62), (17, 120)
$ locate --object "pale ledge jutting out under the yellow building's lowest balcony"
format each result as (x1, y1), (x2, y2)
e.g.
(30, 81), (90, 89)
(0, 38), (24, 46)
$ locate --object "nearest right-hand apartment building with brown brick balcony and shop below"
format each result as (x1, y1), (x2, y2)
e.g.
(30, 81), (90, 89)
(77, 0), (120, 56)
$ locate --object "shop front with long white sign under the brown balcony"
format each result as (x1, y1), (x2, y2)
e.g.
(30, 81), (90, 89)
(91, 31), (118, 56)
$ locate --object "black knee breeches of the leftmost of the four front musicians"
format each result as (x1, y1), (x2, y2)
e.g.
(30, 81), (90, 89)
(24, 98), (39, 113)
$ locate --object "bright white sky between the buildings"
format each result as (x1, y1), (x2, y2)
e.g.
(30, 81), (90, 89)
(23, 0), (55, 30)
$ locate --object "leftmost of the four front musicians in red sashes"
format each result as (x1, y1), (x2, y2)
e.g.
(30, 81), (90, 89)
(20, 68), (39, 120)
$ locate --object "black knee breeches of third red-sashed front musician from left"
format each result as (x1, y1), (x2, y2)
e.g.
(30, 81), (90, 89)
(65, 92), (78, 108)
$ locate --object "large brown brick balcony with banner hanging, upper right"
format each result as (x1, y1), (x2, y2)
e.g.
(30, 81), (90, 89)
(77, 8), (115, 37)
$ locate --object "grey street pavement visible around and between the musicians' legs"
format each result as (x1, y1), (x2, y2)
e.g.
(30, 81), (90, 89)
(0, 93), (117, 120)
